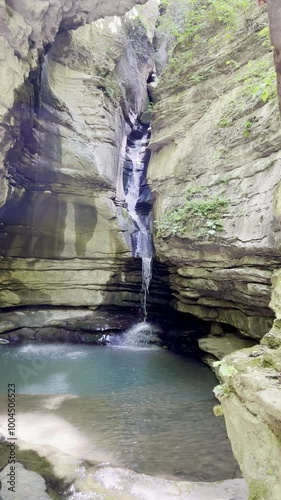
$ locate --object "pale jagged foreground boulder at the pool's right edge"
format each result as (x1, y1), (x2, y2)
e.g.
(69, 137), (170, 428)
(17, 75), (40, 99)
(219, 342), (281, 500)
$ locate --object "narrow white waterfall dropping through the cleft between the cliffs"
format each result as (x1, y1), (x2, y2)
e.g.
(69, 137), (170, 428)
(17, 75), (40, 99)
(124, 122), (154, 320)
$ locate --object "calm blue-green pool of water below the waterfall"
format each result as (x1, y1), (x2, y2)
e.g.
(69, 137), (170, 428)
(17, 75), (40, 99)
(0, 343), (236, 481)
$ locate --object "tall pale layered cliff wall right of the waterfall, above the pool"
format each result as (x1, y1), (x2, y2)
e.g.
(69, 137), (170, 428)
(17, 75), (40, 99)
(148, 3), (281, 339)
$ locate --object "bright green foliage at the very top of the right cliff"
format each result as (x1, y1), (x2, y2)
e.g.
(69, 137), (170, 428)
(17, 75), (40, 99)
(158, 0), (253, 86)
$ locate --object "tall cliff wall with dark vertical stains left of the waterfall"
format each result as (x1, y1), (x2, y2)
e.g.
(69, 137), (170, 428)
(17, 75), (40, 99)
(0, 0), (162, 307)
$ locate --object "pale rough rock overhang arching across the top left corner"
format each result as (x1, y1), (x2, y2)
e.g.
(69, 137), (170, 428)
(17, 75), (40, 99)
(0, 0), (149, 204)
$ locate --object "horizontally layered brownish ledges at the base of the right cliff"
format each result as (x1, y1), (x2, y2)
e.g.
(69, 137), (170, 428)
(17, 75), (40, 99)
(165, 254), (277, 339)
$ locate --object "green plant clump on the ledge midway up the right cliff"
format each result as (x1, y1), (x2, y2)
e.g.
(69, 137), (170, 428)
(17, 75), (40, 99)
(156, 186), (228, 239)
